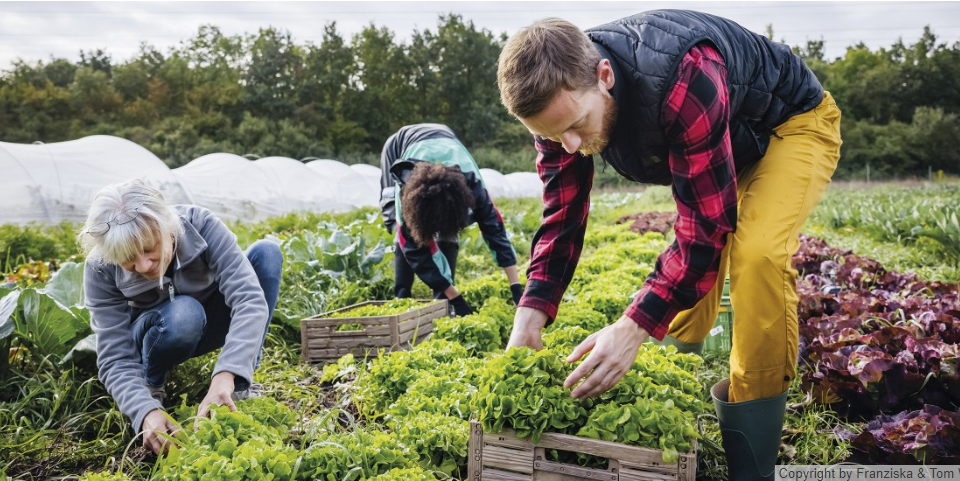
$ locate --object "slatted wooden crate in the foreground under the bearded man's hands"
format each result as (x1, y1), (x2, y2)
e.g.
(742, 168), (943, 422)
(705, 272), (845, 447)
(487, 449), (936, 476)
(467, 421), (697, 481)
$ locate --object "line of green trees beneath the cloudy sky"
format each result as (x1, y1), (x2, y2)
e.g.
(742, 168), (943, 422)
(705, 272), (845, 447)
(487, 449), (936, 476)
(0, 14), (960, 185)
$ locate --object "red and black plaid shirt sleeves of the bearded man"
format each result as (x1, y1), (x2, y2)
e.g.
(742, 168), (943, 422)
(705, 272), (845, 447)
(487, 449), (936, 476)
(520, 44), (737, 339)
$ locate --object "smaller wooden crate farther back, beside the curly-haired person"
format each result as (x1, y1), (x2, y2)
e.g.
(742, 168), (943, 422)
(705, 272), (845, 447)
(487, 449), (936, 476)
(300, 299), (447, 363)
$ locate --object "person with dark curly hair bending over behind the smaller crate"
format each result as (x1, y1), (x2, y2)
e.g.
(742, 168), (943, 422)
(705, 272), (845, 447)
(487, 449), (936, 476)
(380, 124), (523, 316)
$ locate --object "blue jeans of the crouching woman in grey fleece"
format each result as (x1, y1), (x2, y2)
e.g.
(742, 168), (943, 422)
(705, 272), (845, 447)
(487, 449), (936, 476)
(133, 240), (283, 386)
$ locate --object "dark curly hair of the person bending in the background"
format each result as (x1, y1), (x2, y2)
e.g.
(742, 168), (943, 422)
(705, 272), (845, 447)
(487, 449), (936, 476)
(400, 162), (474, 244)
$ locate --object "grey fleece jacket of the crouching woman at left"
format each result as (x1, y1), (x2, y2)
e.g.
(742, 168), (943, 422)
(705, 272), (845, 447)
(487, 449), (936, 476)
(83, 206), (269, 431)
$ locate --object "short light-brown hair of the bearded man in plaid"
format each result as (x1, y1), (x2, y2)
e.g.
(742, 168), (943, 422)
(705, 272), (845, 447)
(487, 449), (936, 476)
(497, 18), (602, 119)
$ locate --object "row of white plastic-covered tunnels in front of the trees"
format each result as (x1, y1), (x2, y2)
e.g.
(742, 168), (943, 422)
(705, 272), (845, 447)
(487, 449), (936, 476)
(0, 135), (542, 224)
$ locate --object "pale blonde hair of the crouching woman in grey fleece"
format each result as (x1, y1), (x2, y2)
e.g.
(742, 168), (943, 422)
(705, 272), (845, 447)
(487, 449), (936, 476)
(77, 179), (183, 279)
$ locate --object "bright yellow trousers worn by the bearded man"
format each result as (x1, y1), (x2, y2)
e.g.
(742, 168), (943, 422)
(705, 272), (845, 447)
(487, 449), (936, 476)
(668, 92), (841, 402)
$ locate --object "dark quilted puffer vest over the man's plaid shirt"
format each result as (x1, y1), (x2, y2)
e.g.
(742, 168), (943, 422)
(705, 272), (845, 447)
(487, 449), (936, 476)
(586, 10), (823, 185)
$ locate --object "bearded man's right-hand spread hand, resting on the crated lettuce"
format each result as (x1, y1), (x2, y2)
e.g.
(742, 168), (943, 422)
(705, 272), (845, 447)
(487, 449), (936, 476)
(563, 316), (650, 398)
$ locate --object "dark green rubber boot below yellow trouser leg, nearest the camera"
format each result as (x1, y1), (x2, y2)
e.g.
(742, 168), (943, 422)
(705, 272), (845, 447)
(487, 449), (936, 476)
(710, 379), (787, 481)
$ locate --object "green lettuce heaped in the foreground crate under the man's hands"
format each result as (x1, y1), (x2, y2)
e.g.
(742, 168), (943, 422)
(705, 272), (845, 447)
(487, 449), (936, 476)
(475, 344), (704, 463)
